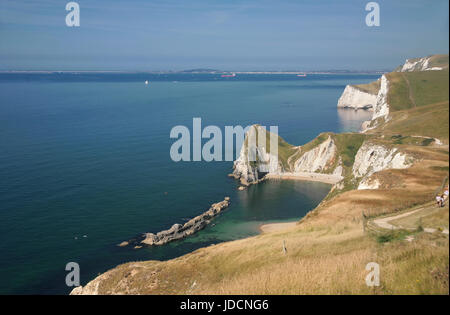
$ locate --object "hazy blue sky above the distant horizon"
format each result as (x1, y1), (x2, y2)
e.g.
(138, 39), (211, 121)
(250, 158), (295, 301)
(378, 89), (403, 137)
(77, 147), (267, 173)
(0, 0), (449, 71)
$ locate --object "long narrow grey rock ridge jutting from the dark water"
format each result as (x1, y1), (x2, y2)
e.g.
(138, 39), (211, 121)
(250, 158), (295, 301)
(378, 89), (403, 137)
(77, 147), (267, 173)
(141, 197), (230, 246)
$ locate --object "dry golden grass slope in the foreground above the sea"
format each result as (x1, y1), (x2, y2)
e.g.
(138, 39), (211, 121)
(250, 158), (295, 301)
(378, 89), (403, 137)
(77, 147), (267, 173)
(88, 215), (448, 294)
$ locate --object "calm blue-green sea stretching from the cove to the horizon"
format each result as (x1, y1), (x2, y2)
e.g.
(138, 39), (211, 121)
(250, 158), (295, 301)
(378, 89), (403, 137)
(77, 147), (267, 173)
(0, 74), (378, 294)
